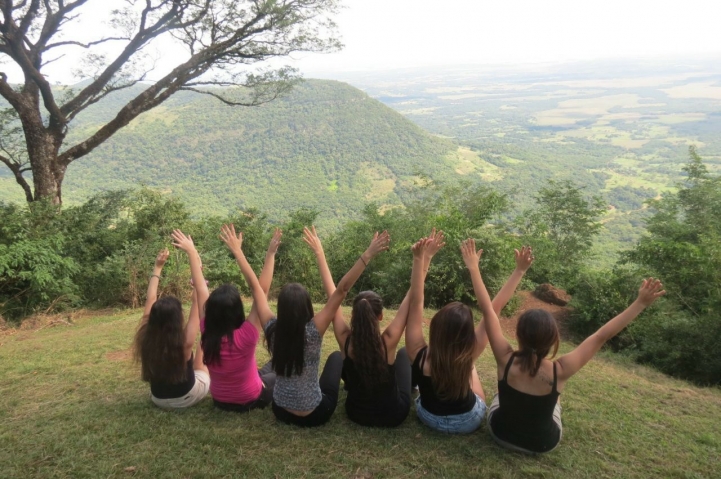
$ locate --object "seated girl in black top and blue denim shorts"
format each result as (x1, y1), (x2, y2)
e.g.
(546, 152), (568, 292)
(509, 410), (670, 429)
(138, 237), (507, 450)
(406, 242), (530, 434)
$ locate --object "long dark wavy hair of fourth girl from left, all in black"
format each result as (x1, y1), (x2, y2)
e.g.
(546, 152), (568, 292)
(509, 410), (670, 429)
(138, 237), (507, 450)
(350, 291), (388, 389)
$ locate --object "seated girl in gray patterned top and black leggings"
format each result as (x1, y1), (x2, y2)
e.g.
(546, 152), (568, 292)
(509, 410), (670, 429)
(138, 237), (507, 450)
(265, 231), (389, 427)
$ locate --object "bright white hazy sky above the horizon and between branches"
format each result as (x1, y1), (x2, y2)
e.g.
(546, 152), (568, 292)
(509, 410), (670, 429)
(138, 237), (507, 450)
(2, 0), (721, 83)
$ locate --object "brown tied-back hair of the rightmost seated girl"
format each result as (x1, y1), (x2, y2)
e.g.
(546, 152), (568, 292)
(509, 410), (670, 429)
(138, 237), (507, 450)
(516, 309), (561, 377)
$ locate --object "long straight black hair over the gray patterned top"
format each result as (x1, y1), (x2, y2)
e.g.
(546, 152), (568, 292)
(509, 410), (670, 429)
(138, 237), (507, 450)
(265, 283), (314, 377)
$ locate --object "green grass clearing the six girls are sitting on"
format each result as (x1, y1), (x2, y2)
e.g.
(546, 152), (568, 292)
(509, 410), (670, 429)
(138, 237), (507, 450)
(0, 311), (721, 479)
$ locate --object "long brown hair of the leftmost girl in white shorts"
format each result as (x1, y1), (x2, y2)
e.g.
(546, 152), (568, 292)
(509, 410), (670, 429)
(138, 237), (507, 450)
(134, 296), (187, 384)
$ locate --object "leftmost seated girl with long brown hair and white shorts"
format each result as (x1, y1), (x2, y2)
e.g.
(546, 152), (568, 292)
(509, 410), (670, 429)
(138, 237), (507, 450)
(135, 243), (210, 409)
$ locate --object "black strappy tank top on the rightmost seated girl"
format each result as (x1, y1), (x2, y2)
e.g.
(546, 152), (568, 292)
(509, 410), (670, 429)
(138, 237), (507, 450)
(490, 353), (561, 452)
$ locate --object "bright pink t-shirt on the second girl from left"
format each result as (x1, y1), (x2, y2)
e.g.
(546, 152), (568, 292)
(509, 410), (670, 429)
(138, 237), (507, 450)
(200, 318), (263, 404)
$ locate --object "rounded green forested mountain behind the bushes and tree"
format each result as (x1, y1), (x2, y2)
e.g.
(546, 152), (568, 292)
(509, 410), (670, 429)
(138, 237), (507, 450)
(8, 80), (458, 223)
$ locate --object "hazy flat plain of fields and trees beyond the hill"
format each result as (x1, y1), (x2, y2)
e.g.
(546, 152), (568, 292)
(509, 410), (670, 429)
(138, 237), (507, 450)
(334, 58), (721, 263)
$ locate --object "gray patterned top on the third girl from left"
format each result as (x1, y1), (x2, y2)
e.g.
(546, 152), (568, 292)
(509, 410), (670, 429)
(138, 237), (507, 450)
(265, 319), (323, 411)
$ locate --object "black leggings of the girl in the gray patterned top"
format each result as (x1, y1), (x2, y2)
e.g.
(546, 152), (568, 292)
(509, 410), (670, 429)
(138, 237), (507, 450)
(273, 351), (343, 427)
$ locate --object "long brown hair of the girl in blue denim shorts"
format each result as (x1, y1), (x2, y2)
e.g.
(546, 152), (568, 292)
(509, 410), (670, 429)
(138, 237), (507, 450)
(428, 302), (476, 401)
